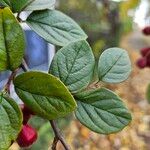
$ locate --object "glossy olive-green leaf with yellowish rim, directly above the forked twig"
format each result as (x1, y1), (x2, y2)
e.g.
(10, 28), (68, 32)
(14, 71), (76, 120)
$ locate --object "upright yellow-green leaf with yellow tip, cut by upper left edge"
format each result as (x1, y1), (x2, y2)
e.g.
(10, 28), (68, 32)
(0, 7), (25, 71)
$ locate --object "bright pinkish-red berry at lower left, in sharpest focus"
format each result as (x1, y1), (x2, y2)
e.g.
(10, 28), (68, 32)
(17, 124), (38, 147)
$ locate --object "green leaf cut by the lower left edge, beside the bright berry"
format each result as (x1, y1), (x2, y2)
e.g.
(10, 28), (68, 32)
(0, 94), (22, 150)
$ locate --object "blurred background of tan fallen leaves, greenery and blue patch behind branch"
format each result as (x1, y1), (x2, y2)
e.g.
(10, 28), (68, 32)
(0, 0), (150, 150)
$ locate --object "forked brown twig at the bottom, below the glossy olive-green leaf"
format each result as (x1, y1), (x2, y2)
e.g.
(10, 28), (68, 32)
(50, 120), (70, 150)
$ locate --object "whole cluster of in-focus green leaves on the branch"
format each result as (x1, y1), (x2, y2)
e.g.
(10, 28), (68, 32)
(0, 0), (131, 150)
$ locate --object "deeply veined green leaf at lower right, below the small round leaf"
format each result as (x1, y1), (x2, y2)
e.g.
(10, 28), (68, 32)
(75, 88), (131, 134)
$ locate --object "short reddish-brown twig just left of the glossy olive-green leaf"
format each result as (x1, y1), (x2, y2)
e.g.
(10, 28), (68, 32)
(5, 68), (19, 94)
